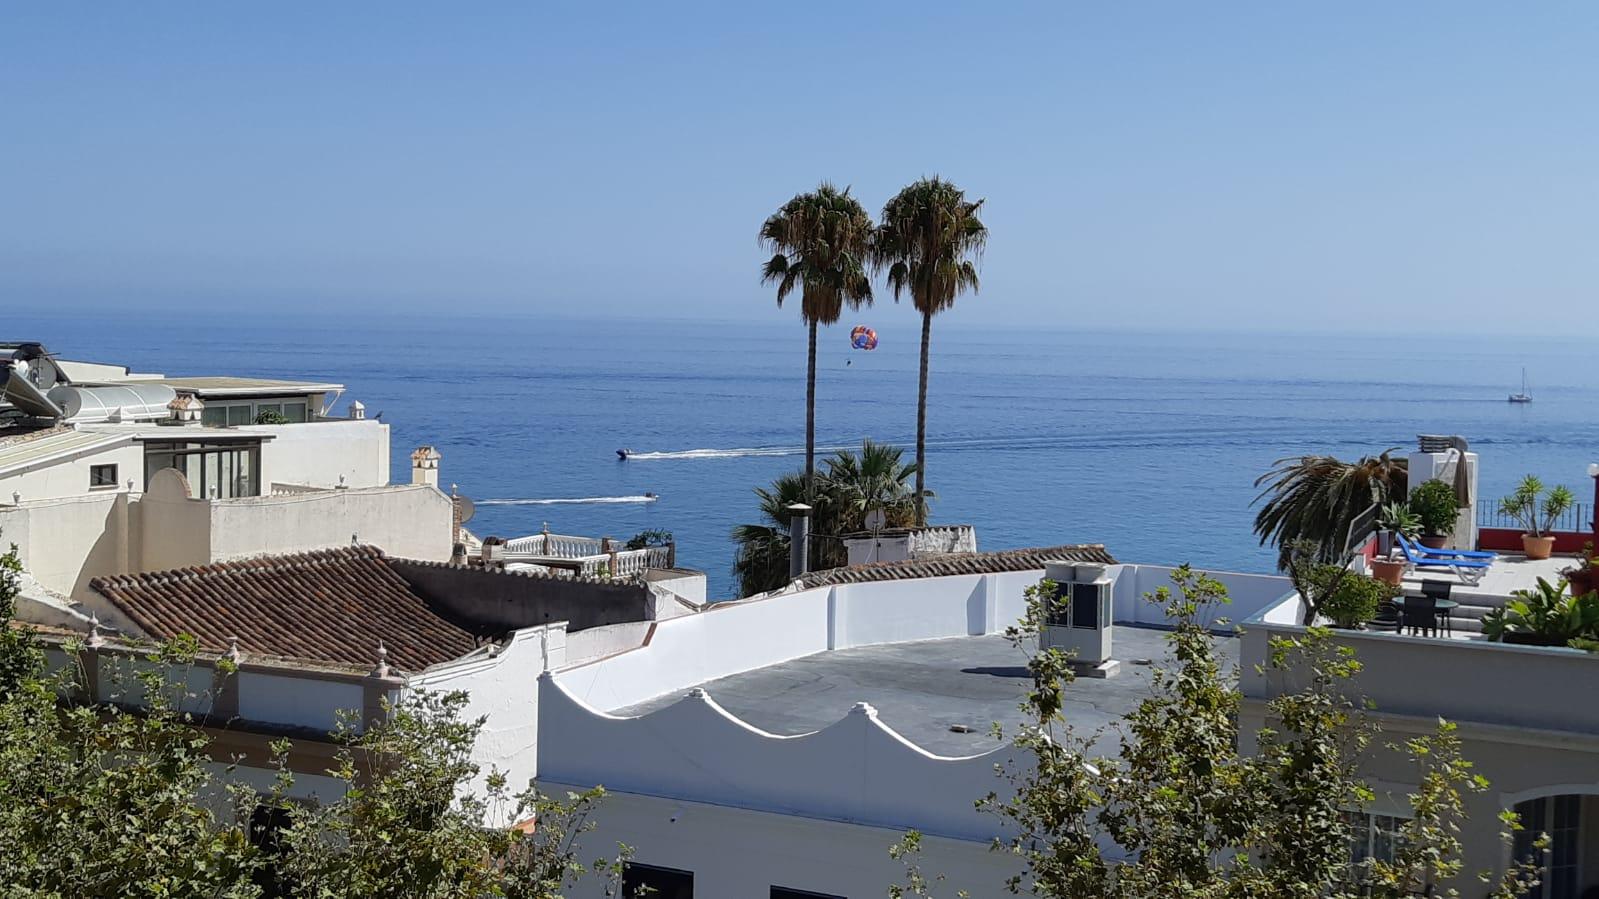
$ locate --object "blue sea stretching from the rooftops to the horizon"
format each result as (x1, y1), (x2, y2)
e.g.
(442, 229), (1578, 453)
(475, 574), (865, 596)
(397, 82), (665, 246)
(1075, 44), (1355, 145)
(0, 310), (1599, 597)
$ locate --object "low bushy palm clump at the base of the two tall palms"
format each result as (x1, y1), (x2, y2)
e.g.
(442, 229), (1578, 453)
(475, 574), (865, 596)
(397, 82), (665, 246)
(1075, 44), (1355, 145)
(732, 440), (916, 597)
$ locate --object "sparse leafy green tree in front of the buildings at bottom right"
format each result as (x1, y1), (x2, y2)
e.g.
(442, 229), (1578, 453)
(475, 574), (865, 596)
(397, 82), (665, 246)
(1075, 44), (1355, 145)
(889, 566), (1541, 899)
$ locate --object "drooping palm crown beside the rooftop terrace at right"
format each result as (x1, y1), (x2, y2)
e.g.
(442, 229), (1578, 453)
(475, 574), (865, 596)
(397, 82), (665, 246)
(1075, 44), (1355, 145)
(1255, 448), (1409, 569)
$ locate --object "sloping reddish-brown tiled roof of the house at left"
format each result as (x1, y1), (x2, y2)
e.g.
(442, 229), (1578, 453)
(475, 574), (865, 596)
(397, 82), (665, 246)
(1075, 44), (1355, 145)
(90, 545), (486, 672)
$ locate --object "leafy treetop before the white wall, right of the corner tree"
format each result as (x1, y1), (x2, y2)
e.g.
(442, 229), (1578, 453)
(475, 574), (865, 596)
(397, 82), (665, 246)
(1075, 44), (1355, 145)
(265, 693), (620, 899)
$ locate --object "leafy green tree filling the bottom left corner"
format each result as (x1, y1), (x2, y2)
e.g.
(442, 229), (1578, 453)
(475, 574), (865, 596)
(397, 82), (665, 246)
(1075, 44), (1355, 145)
(0, 537), (259, 899)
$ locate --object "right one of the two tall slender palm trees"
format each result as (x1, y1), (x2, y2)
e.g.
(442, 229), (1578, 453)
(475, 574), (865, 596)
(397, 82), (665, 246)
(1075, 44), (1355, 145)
(873, 176), (988, 525)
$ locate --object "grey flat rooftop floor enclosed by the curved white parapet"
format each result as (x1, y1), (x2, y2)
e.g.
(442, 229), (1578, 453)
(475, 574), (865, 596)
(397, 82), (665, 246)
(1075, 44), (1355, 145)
(612, 625), (1238, 757)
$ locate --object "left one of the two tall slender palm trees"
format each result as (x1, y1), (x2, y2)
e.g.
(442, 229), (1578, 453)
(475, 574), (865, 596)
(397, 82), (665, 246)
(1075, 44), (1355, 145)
(761, 181), (873, 496)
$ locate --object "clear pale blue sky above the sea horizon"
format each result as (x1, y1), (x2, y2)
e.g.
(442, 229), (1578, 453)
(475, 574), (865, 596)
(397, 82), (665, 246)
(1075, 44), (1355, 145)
(0, 2), (1599, 333)
